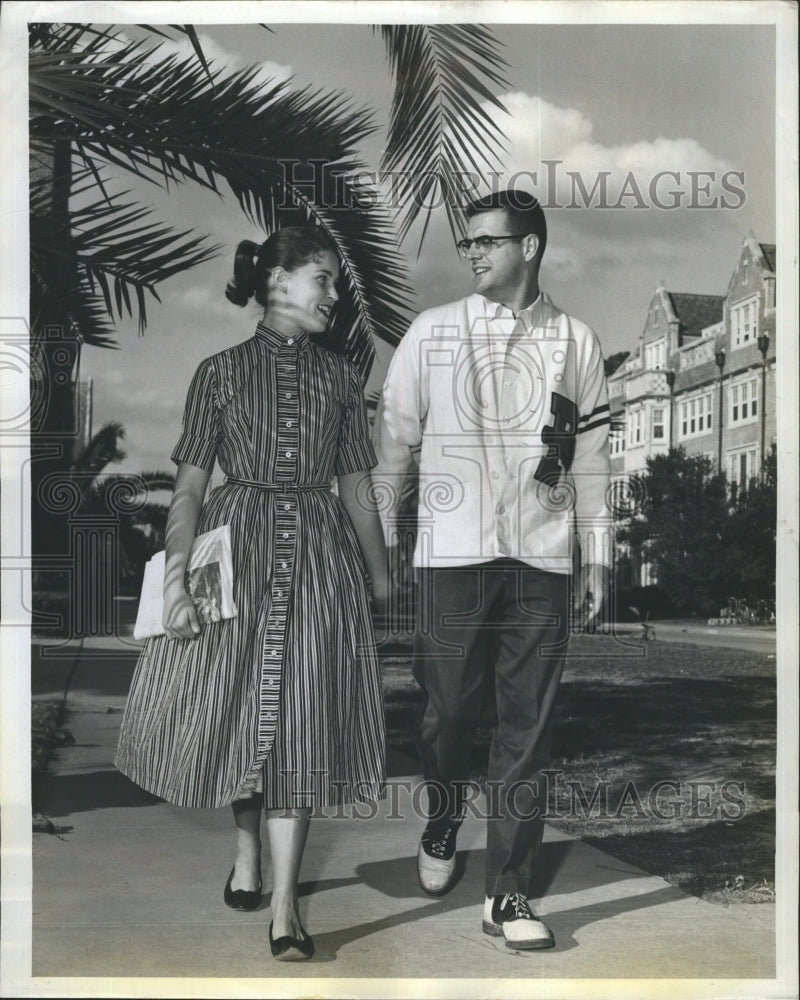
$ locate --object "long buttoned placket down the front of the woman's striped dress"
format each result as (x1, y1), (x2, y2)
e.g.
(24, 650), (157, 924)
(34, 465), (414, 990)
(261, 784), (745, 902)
(259, 345), (299, 756)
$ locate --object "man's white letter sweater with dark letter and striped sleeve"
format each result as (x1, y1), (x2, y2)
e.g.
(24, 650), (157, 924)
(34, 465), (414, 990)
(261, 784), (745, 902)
(373, 294), (611, 573)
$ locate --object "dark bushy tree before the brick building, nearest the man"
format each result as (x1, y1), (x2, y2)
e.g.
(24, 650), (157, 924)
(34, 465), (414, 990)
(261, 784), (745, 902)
(617, 448), (730, 615)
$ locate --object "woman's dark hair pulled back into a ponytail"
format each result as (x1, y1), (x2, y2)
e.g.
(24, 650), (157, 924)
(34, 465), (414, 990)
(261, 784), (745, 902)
(225, 226), (337, 309)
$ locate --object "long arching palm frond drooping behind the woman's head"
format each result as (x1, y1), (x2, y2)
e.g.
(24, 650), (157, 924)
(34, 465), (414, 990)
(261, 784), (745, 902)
(30, 29), (410, 378)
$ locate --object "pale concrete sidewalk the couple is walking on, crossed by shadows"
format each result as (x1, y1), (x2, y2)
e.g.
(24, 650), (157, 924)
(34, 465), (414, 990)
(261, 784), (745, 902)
(32, 642), (775, 995)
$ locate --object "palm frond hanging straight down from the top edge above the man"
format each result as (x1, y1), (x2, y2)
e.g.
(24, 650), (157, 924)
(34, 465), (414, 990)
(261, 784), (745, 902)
(381, 24), (508, 247)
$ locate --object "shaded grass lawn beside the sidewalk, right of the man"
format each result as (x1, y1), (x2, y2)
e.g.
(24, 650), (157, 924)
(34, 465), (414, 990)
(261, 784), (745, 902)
(382, 635), (776, 903)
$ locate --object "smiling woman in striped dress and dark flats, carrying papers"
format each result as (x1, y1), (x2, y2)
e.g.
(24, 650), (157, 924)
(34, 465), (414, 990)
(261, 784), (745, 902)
(115, 227), (387, 960)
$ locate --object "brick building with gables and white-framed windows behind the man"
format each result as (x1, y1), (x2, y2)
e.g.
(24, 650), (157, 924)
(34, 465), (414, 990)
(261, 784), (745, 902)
(608, 232), (776, 585)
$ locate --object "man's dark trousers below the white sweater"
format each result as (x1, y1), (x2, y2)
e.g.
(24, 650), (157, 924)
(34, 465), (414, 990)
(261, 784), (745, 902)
(414, 559), (570, 895)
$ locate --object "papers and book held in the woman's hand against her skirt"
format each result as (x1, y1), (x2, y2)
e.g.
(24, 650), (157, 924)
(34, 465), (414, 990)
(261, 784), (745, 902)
(133, 524), (239, 639)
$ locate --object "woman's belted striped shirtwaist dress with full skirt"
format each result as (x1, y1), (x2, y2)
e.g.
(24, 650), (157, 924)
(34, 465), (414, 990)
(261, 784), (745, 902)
(115, 324), (385, 808)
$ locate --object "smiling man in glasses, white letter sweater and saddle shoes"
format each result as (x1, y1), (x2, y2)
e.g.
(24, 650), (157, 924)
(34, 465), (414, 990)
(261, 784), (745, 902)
(374, 190), (610, 949)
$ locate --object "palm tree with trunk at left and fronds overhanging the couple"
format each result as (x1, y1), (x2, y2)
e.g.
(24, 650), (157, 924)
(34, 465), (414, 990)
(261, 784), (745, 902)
(29, 24), (505, 628)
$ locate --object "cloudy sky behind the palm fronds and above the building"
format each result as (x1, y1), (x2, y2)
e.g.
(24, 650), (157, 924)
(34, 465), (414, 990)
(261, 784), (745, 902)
(56, 17), (775, 472)
